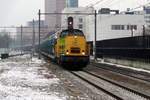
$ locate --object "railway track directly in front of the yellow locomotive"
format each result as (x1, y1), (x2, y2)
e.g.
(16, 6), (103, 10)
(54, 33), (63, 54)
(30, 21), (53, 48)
(71, 71), (150, 100)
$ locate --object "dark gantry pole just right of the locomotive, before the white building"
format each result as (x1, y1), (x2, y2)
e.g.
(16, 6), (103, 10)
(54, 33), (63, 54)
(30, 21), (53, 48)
(93, 10), (97, 61)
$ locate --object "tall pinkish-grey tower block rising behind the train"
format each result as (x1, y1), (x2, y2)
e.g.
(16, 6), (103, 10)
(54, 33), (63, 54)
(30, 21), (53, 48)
(45, 0), (66, 31)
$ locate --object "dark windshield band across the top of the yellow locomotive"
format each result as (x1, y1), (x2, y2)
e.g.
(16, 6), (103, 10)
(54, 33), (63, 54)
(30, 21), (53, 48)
(60, 29), (84, 37)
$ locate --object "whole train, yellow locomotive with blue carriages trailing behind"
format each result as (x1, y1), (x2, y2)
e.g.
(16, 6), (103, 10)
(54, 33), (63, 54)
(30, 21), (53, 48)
(40, 18), (90, 68)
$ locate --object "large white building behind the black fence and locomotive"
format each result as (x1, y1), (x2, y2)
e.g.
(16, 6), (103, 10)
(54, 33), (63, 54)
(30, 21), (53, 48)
(62, 8), (145, 41)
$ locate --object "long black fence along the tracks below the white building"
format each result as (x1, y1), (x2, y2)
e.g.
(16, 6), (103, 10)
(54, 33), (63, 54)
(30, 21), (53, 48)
(89, 36), (150, 62)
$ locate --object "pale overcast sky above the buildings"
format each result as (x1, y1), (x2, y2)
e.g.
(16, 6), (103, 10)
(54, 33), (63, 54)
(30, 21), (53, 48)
(0, 0), (149, 26)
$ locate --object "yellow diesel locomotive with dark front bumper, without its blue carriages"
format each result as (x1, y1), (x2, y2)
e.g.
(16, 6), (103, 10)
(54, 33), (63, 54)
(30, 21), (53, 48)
(54, 29), (89, 66)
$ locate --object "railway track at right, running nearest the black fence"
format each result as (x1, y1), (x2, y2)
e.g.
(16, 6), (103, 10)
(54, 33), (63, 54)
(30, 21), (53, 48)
(91, 63), (150, 83)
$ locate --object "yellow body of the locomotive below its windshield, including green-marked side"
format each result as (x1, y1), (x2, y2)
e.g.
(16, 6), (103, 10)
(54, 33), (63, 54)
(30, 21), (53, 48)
(55, 36), (89, 58)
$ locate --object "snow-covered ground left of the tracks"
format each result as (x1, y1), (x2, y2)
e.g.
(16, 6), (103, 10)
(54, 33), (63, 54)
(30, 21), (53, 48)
(0, 55), (67, 100)
